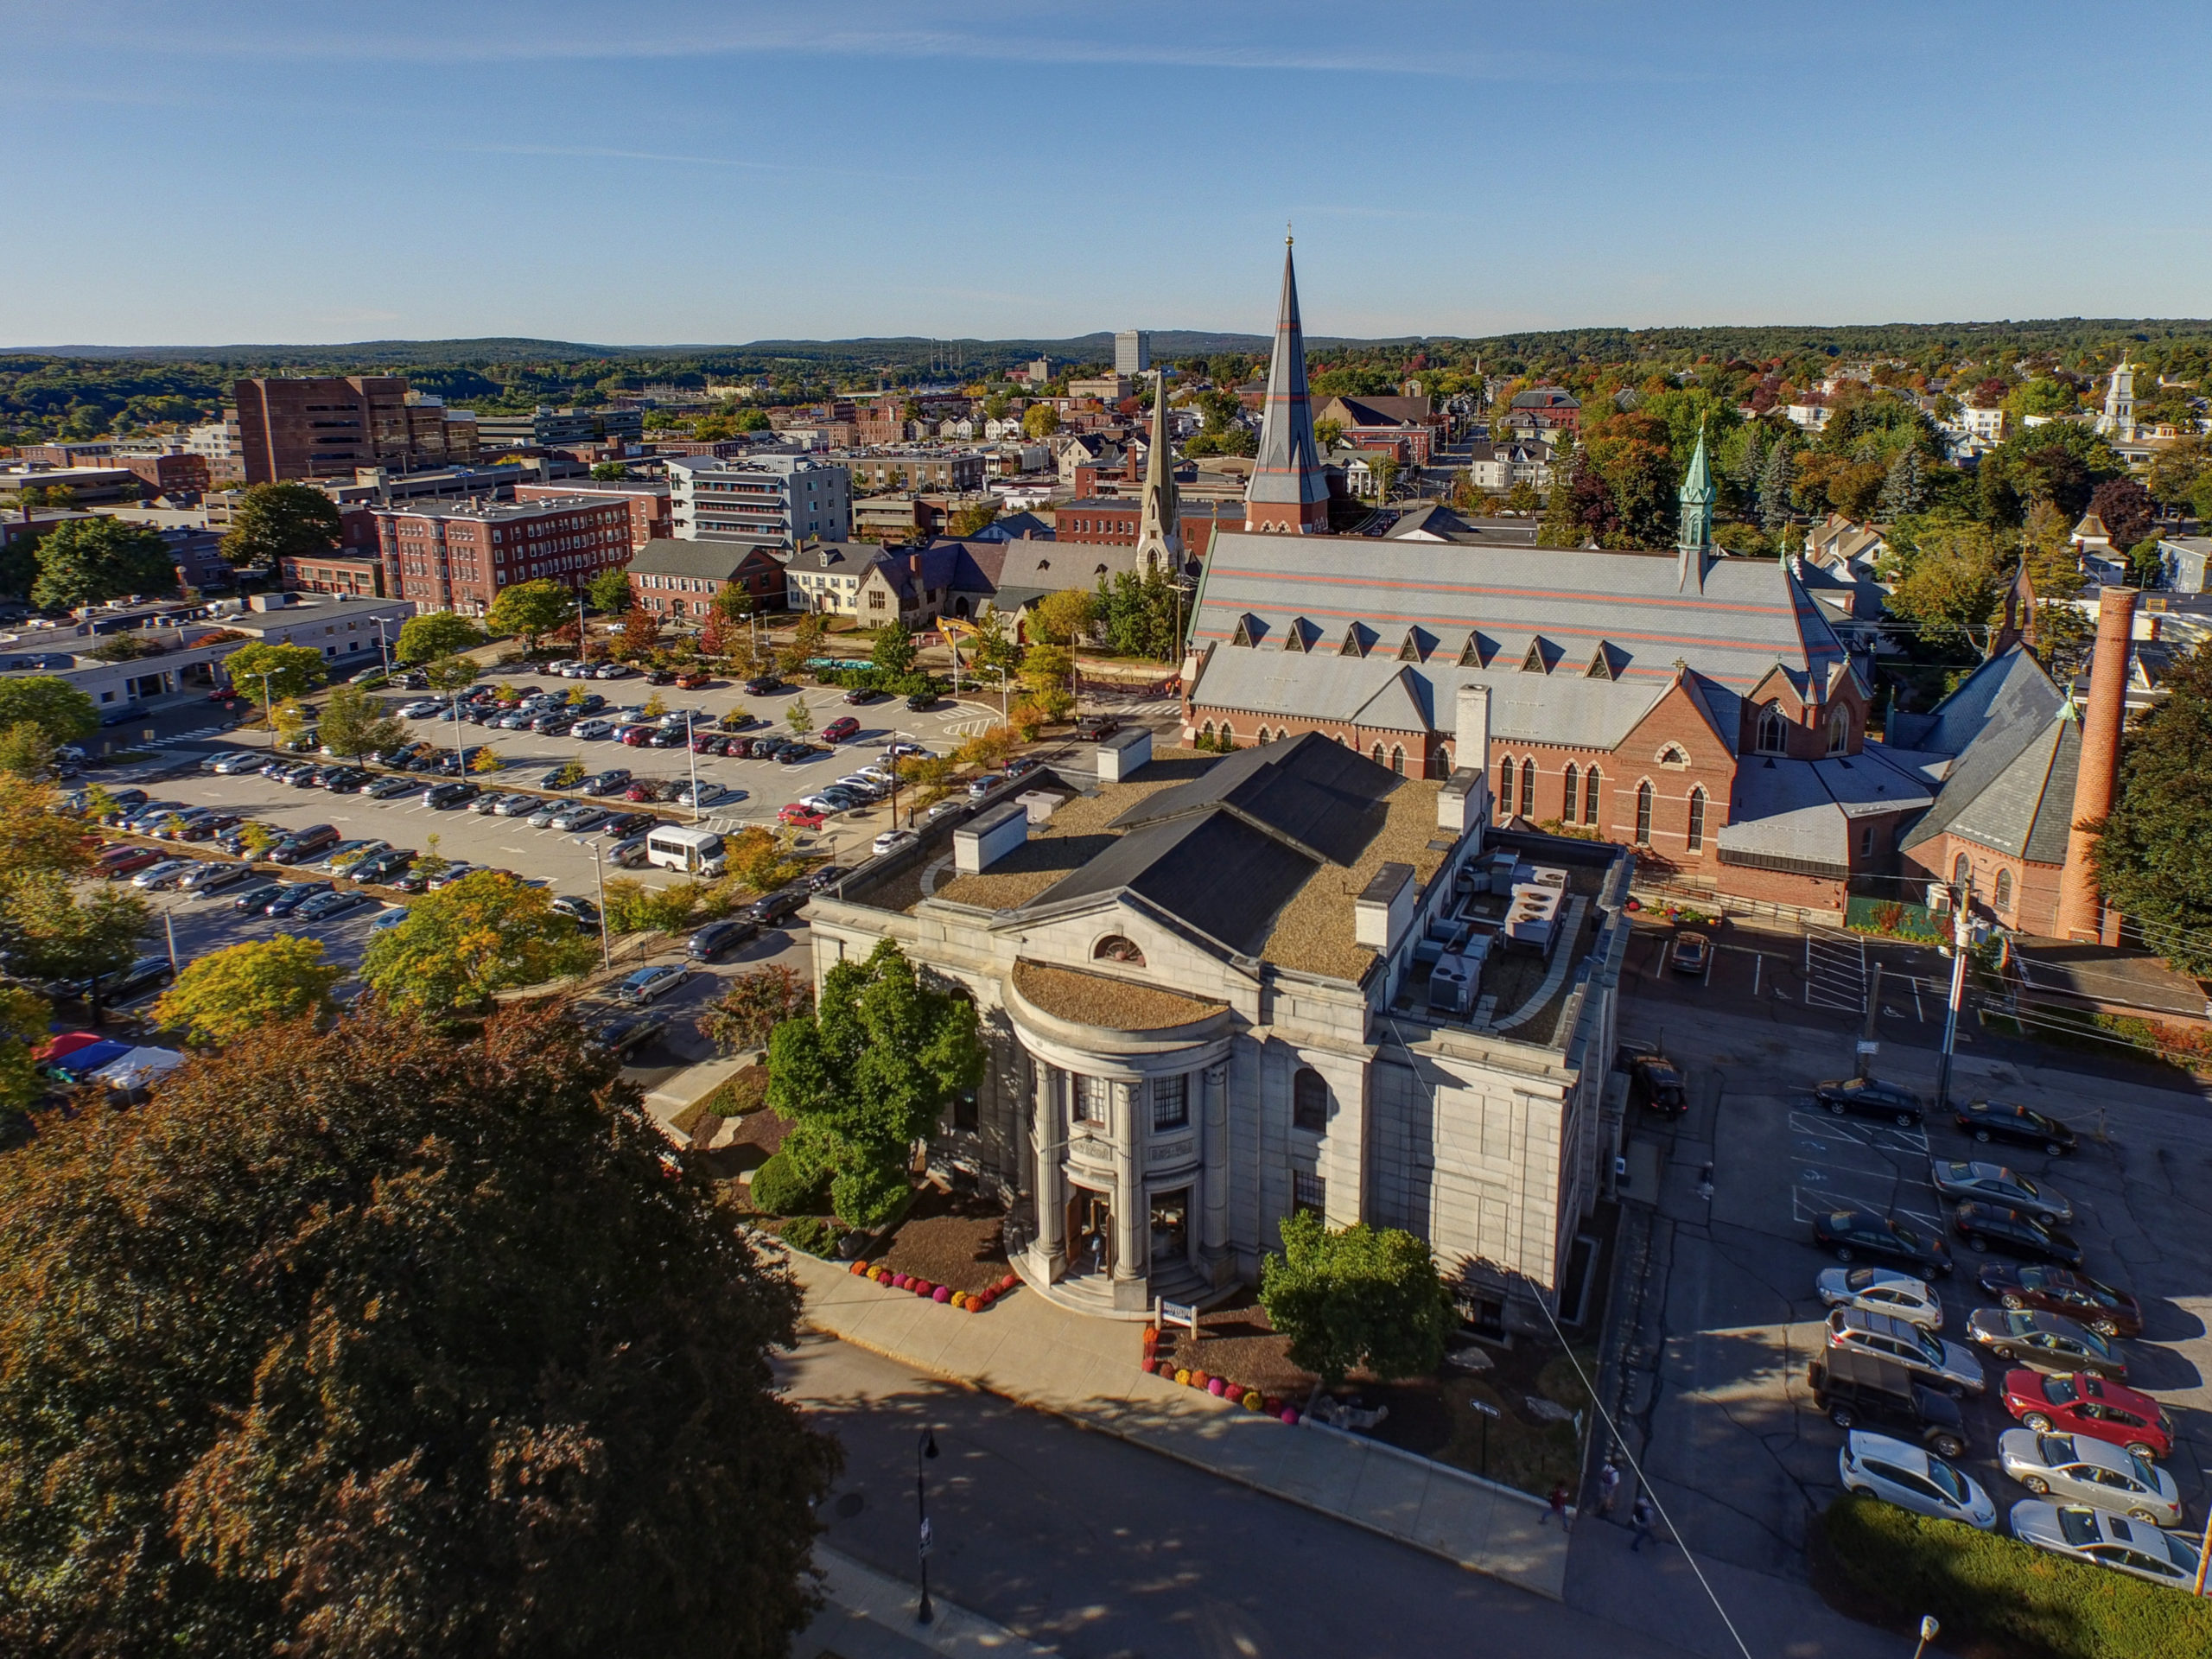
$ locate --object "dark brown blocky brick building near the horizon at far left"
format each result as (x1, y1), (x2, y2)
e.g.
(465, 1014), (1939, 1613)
(234, 385), (475, 485)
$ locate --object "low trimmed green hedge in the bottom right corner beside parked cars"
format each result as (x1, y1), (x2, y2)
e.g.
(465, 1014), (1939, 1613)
(1821, 1496), (2212, 1659)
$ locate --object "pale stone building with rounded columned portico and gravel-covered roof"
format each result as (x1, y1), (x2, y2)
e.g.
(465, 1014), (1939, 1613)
(810, 716), (1630, 1330)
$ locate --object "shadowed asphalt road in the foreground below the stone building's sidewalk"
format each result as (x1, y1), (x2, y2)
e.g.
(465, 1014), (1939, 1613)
(779, 1336), (1725, 1659)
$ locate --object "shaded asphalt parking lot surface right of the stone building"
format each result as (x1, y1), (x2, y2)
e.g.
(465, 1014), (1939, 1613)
(1621, 955), (2212, 1580)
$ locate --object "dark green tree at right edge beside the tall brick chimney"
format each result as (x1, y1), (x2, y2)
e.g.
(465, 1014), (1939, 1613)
(2094, 646), (2212, 978)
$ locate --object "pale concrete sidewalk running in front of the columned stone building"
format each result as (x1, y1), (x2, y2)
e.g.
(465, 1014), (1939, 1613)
(790, 1249), (1566, 1601)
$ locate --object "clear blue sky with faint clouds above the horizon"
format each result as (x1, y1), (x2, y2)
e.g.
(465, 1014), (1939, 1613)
(0, 0), (2212, 345)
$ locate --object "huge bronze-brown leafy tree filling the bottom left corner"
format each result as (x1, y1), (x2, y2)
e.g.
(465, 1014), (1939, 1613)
(0, 1007), (838, 1659)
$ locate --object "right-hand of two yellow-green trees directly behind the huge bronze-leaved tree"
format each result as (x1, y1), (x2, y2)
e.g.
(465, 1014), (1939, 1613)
(360, 869), (600, 1013)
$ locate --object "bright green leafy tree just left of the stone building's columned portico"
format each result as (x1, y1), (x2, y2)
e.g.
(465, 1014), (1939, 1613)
(767, 940), (984, 1228)
